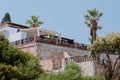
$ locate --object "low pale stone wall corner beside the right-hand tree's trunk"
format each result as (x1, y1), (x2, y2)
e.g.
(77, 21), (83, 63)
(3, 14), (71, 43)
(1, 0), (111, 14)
(77, 61), (105, 76)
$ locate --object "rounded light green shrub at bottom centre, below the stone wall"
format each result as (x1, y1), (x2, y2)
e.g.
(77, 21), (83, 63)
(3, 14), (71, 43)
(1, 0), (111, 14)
(37, 63), (81, 80)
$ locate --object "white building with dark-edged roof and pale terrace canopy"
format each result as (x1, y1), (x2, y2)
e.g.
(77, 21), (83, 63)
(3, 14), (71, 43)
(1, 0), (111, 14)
(0, 22), (61, 42)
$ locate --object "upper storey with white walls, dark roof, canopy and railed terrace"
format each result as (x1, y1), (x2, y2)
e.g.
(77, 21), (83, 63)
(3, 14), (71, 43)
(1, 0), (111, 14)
(0, 23), (87, 50)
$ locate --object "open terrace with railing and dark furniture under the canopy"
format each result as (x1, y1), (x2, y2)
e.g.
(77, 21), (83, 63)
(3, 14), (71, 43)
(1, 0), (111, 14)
(11, 35), (87, 50)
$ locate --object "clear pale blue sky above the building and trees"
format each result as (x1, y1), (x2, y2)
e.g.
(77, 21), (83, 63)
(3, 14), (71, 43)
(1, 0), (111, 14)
(0, 0), (120, 44)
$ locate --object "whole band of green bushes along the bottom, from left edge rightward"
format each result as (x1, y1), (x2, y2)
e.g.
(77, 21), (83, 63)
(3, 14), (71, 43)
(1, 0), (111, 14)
(0, 36), (105, 80)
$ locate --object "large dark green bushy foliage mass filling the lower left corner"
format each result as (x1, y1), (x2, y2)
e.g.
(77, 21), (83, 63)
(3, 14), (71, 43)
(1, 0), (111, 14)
(0, 36), (43, 80)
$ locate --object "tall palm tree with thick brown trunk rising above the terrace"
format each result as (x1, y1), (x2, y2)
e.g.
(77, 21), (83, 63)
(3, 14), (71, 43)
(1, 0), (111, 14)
(84, 9), (103, 44)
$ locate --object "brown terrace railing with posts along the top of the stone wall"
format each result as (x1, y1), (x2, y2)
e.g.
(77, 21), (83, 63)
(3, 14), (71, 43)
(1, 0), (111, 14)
(11, 36), (87, 50)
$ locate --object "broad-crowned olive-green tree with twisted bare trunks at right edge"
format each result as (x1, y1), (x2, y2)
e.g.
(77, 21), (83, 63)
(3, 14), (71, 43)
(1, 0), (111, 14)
(89, 33), (120, 80)
